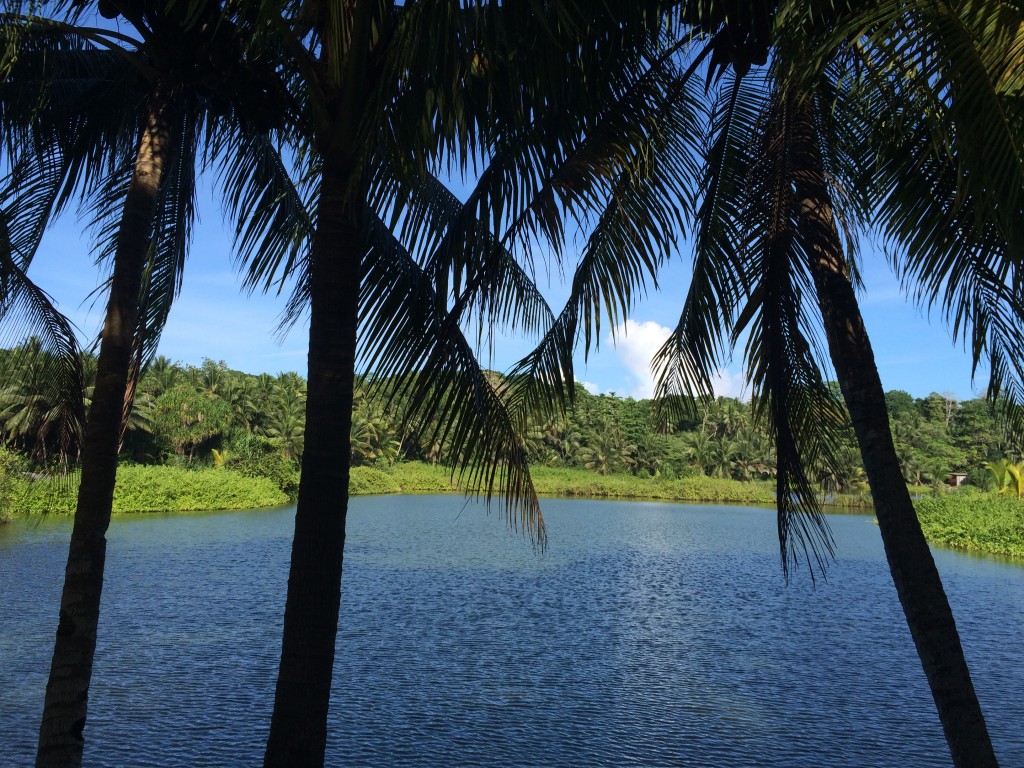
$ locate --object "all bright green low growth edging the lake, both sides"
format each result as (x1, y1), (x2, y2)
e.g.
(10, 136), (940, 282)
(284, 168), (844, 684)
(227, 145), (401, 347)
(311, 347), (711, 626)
(6, 462), (1024, 558)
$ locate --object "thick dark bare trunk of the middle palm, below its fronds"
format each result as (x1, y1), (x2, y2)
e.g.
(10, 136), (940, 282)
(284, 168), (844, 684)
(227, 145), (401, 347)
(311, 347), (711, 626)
(264, 169), (365, 768)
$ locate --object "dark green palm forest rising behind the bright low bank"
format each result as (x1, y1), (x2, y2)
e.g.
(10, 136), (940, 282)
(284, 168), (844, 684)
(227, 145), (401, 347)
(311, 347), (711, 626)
(0, 340), (1022, 495)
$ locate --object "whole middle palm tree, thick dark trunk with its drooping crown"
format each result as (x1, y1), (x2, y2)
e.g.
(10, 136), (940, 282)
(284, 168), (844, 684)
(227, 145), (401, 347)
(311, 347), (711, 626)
(220, 6), (700, 765)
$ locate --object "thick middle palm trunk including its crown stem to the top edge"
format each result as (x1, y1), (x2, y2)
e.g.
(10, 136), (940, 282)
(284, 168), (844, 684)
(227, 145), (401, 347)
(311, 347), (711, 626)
(263, 0), (380, 768)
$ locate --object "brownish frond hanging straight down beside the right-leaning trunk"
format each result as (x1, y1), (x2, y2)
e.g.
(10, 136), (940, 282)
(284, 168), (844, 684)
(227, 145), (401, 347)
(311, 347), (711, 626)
(734, 86), (846, 575)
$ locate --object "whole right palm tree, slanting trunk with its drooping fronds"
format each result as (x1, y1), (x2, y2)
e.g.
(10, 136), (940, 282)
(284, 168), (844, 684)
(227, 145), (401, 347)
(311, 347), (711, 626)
(658, 4), (1022, 765)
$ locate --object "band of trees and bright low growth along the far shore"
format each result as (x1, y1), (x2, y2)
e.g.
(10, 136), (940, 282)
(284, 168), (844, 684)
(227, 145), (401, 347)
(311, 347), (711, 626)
(0, 342), (1021, 520)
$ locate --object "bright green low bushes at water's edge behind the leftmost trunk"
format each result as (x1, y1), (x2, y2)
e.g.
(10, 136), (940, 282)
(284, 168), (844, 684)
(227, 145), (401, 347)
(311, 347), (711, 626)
(11, 466), (288, 514)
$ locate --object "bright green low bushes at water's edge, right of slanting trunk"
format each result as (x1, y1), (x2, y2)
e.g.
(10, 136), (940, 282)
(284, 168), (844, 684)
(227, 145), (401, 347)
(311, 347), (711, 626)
(914, 488), (1024, 557)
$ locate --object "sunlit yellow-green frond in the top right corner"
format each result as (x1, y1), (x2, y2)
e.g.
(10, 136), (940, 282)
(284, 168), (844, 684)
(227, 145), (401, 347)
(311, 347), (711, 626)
(851, 2), (1024, 249)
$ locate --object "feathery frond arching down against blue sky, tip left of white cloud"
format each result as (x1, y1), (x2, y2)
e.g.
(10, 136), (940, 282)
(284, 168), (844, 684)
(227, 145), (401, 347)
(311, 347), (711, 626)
(510, 55), (699, 421)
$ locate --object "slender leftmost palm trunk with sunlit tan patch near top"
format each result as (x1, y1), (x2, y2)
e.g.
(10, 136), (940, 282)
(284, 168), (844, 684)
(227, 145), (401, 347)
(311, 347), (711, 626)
(36, 91), (174, 768)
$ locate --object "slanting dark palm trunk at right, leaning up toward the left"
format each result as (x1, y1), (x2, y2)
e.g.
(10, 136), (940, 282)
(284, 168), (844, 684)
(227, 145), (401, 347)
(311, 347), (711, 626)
(797, 103), (998, 768)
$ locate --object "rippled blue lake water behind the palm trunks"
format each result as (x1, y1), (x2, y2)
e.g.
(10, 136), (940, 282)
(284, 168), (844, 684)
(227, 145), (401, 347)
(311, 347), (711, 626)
(0, 497), (1024, 768)
